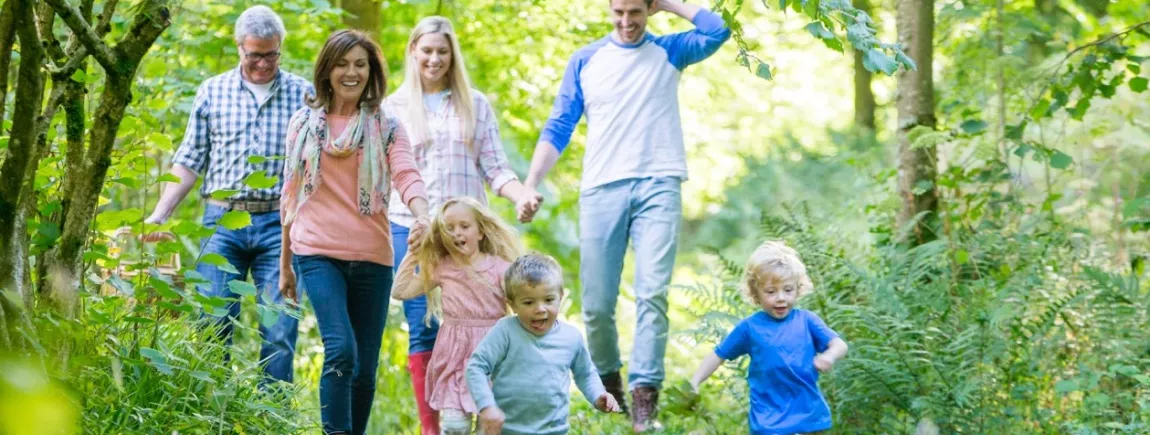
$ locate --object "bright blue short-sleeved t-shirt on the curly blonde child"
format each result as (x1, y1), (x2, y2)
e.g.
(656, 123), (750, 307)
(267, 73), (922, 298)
(715, 308), (838, 435)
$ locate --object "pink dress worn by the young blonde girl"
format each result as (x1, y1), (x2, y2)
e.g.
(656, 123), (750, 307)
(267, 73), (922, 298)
(427, 255), (511, 413)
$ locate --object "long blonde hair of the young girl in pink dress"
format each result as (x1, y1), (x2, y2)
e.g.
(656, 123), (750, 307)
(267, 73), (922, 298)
(416, 197), (523, 322)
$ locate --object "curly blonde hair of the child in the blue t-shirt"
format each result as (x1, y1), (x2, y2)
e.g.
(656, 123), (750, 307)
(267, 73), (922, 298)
(739, 241), (814, 304)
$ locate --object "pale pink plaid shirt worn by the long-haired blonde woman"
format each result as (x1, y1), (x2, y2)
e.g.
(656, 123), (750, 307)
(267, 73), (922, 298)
(383, 89), (519, 227)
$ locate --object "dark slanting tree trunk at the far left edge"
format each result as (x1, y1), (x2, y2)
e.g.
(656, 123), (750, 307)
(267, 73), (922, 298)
(0, 0), (44, 289)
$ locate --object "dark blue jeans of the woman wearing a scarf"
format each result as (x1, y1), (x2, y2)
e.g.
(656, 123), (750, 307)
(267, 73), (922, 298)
(292, 255), (392, 435)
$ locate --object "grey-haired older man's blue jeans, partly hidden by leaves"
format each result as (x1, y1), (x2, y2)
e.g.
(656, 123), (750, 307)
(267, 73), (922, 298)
(196, 204), (298, 382)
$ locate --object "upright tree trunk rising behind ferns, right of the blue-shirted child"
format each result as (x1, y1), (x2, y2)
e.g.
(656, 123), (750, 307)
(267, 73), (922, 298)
(897, 0), (938, 245)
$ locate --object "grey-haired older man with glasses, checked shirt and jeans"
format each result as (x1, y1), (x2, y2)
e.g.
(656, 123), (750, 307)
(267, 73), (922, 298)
(145, 6), (314, 382)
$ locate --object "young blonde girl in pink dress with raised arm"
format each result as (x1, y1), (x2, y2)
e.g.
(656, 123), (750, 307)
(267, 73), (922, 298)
(392, 197), (521, 435)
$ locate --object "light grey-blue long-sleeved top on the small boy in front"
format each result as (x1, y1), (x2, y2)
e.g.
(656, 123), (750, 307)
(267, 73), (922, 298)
(467, 315), (607, 435)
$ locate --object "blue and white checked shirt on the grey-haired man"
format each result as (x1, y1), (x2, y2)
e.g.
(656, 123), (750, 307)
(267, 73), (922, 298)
(173, 67), (314, 201)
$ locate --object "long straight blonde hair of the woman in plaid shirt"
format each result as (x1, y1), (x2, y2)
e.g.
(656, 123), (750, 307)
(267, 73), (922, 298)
(403, 16), (475, 150)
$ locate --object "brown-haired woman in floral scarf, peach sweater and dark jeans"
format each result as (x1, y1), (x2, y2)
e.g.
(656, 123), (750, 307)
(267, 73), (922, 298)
(279, 30), (428, 435)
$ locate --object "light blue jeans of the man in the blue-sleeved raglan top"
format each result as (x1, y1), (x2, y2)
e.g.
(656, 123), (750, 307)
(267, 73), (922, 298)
(580, 177), (683, 388)
